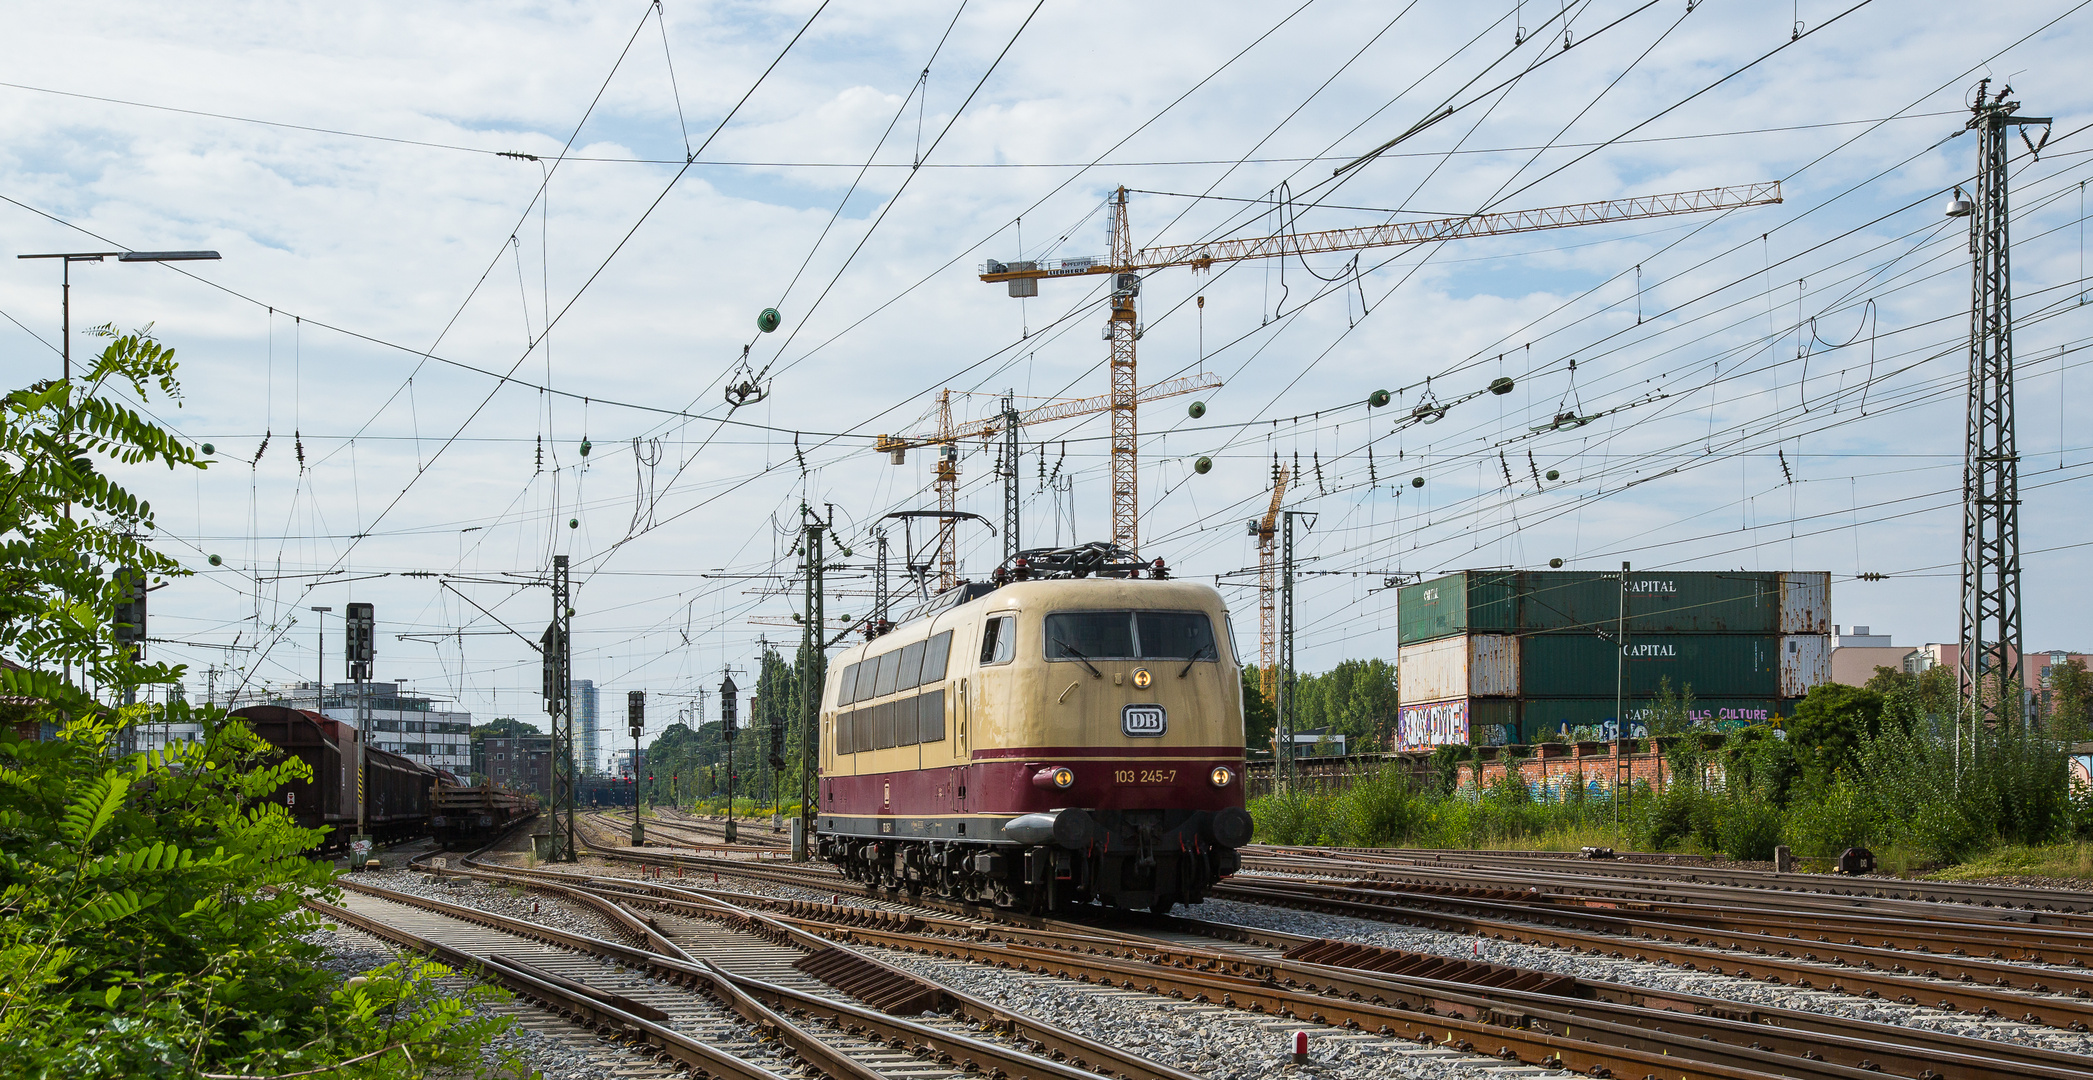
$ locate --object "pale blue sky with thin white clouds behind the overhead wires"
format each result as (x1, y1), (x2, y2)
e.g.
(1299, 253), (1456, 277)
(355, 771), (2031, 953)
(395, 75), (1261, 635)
(0, 0), (2093, 757)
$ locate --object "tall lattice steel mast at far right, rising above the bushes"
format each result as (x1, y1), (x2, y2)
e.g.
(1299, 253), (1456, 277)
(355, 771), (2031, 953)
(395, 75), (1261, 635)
(1949, 80), (2049, 774)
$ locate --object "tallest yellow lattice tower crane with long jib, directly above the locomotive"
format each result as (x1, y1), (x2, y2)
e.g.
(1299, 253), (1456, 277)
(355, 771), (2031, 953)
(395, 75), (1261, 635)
(982, 182), (1781, 550)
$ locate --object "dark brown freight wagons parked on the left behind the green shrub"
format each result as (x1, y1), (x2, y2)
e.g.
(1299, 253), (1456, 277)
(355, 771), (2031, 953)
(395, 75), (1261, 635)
(232, 705), (538, 850)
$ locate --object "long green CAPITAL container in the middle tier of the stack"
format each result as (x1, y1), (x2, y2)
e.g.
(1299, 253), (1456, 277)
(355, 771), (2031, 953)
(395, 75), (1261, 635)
(1520, 632), (1781, 701)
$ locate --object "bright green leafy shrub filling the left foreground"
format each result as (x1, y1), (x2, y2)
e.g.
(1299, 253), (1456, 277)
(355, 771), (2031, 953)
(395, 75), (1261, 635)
(0, 333), (504, 1080)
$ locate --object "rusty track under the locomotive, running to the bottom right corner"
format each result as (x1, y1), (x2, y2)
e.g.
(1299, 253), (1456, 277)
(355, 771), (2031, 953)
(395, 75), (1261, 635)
(502, 820), (2093, 1078)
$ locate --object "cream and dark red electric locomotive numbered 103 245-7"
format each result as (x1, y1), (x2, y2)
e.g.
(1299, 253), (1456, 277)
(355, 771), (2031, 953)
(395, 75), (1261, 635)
(816, 544), (1252, 913)
